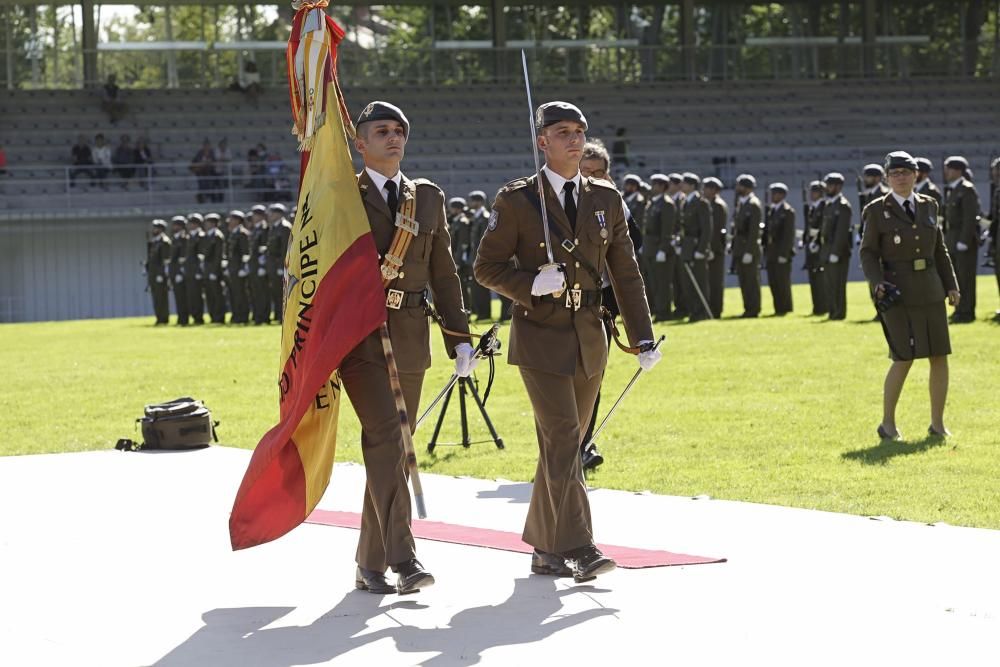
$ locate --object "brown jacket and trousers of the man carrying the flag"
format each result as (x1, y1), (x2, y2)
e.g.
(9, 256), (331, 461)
(340, 170), (469, 572)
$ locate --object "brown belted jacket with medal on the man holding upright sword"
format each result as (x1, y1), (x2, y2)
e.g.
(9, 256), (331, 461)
(474, 175), (653, 377)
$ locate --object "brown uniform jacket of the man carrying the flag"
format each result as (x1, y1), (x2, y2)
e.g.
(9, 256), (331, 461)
(351, 170), (469, 373)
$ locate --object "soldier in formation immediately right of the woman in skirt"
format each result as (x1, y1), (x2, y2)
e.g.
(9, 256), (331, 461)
(944, 155), (980, 324)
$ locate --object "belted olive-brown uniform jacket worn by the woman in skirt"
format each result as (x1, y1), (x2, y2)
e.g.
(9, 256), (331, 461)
(860, 194), (958, 305)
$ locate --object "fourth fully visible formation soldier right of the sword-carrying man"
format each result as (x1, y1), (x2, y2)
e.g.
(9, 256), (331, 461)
(732, 174), (764, 318)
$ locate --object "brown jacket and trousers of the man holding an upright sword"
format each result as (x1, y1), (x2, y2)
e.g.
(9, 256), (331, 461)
(475, 171), (653, 554)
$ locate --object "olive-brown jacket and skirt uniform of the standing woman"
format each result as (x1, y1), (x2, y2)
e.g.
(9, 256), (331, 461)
(861, 194), (958, 361)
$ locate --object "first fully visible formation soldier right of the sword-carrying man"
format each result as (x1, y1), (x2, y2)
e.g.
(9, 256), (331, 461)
(640, 170), (677, 322)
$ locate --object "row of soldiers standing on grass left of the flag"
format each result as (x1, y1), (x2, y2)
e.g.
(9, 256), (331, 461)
(144, 203), (294, 326)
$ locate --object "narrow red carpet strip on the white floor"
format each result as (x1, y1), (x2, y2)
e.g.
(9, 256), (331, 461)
(306, 510), (726, 569)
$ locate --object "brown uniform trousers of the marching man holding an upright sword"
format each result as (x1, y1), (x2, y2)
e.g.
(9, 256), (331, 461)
(520, 360), (603, 553)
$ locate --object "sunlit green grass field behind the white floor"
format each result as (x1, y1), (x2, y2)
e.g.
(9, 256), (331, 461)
(0, 277), (1000, 528)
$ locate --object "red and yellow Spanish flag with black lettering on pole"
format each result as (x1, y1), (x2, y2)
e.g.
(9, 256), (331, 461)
(229, 7), (386, 550)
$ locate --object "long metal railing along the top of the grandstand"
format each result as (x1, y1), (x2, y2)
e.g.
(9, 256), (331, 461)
(0, 38), (1000, 88)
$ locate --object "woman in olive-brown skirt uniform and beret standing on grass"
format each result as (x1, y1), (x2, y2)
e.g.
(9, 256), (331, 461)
(861, 151), (962, 439)
